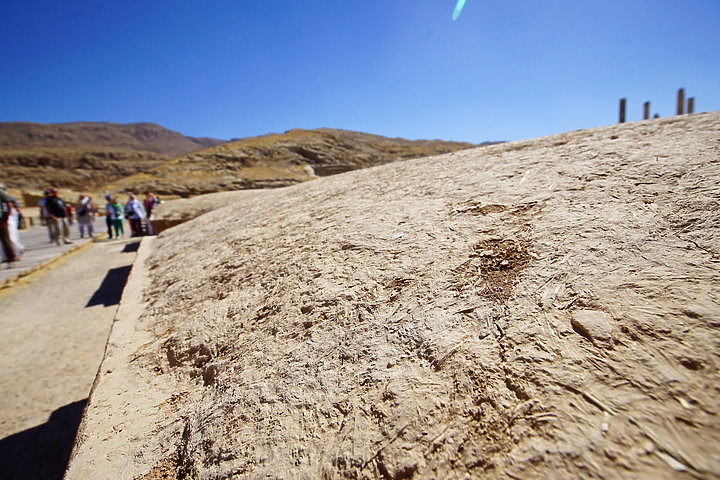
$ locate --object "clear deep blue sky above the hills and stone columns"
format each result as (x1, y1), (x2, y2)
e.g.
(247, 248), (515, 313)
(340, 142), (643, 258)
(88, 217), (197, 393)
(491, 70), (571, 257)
(0, 0), (720, 143)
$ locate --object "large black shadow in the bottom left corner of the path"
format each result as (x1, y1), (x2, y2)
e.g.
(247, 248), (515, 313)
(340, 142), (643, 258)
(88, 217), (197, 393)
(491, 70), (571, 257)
(0, 399), (87, 480)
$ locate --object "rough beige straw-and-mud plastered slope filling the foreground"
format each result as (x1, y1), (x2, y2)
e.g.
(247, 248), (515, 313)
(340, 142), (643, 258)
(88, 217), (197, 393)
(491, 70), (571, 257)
(68, 113), (720, 480)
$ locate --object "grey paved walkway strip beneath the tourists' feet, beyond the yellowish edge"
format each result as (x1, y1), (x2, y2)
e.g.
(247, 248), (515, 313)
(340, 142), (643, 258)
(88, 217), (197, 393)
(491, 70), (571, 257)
(0, 218), (107, 289)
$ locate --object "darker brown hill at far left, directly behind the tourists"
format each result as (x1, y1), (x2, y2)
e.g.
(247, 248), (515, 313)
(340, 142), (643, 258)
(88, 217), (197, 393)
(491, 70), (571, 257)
(0, 122), (222, 190)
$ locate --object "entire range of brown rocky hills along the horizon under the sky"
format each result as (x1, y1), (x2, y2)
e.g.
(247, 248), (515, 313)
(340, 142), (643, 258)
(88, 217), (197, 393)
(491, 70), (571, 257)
(0, 122), (493, 197)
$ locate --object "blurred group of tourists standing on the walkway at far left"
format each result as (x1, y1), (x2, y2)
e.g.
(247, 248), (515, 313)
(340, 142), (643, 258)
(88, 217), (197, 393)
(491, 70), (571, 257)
(0, 183), (160, 262)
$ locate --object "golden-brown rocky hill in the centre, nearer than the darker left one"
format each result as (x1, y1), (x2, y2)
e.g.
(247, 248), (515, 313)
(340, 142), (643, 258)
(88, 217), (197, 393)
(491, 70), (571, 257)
(103, 128), (484, 197)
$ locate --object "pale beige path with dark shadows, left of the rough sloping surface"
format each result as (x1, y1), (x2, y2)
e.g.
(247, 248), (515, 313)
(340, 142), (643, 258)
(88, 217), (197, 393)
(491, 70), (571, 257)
(0, 222), (140, 480)
